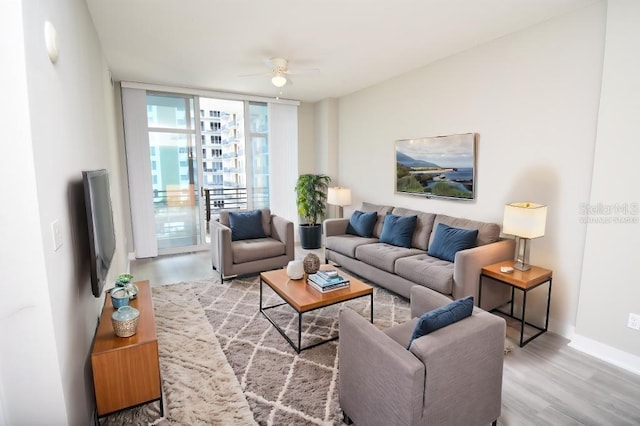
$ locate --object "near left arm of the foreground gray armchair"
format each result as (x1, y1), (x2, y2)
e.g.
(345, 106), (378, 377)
(338, 309), (425, 425)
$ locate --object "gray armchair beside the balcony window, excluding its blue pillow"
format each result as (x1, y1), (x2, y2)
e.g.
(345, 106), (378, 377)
(210, 209), (294, 280)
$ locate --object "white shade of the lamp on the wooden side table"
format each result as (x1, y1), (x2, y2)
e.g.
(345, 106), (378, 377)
(502, 202), (547, 238)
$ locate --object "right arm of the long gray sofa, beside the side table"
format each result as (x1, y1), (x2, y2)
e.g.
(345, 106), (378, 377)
(452, 239), (515, 303)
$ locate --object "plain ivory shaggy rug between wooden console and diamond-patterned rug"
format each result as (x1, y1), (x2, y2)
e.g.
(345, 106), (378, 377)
(100, 284), (255, 425)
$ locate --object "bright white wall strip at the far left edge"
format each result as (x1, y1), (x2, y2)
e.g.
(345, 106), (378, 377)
(0, 1), (67, 425)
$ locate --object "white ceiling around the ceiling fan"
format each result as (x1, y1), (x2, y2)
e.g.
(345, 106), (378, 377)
(87, 0), (595, 102)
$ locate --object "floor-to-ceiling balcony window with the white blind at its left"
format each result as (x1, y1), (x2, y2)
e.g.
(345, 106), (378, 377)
(122, 82), (293, 257)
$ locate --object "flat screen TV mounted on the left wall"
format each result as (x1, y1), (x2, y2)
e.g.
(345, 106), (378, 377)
(82, 169), (116, 297)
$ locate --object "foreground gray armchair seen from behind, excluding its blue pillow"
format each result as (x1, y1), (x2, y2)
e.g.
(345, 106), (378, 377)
(339, 286), (506, 425)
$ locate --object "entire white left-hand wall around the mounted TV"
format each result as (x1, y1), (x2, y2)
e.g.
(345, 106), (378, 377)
(0, 0), (127, 425)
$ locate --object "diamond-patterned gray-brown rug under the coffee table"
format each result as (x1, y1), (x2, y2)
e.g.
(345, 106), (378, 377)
(198, 277), (410, 425)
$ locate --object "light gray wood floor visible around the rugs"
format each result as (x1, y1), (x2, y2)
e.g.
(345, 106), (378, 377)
(131, 247), (640, 426)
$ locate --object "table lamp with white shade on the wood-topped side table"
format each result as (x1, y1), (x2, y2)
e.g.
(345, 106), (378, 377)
(502, 202), (547, 271)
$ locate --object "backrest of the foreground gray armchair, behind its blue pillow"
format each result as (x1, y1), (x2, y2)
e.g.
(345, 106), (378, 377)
(410, 310), (506, 425)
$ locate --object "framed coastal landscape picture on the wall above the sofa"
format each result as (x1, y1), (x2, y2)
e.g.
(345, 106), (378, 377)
(395, 133), (476, 200)
